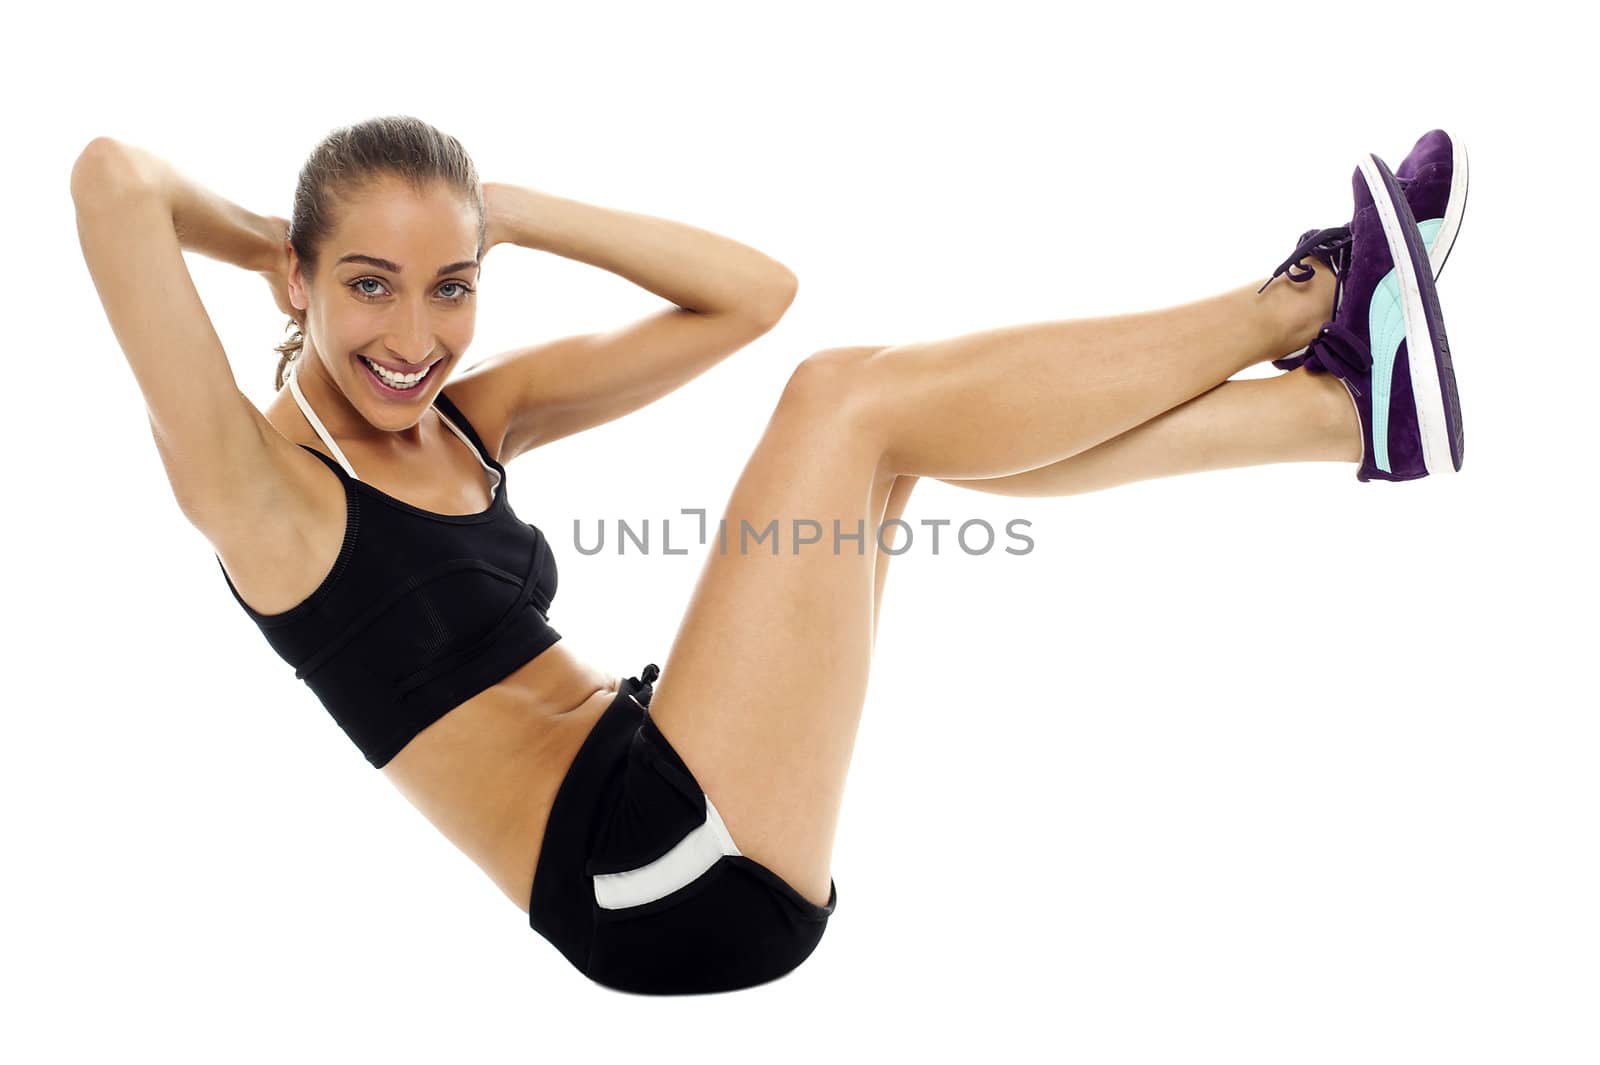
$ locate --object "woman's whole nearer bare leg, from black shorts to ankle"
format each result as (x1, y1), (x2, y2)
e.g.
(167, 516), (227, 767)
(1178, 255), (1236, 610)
(650, 269), (1333, 903)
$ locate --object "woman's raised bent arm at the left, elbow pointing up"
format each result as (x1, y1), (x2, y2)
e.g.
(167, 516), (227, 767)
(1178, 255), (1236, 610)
(72, 138), (308, 542)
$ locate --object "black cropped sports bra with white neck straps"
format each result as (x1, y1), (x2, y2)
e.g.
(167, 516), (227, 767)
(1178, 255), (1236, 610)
(218, 376), (562, 768)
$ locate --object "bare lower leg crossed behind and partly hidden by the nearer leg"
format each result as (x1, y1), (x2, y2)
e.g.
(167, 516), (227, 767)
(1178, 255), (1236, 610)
(946, 366), (1362, 496)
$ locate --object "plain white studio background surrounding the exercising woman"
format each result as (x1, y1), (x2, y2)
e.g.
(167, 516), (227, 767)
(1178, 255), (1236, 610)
(0, 3), (1600, 1065)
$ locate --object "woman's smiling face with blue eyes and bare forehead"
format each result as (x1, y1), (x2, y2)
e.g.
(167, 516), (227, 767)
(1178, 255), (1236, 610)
(290, 178), (478, 430)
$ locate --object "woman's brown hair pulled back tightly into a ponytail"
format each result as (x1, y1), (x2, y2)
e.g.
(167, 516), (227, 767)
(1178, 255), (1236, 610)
(272, 115), (488, 390)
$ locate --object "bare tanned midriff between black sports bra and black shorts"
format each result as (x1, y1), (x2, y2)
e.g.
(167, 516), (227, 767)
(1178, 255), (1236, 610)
(382, 641), (618, 913)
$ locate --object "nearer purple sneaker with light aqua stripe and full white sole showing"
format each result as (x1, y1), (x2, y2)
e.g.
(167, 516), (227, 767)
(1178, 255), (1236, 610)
(1274, 155), (1462, 481)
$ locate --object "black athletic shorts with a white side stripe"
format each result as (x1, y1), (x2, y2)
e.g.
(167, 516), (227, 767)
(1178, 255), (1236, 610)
(528, 664), (838, 995)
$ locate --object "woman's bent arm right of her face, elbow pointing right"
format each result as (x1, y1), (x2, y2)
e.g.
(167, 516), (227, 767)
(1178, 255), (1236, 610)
(461, 182), (798, 462)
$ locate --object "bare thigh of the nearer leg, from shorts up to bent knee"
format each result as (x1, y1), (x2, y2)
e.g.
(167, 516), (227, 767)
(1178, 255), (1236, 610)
(650, 349), (896, 905)
